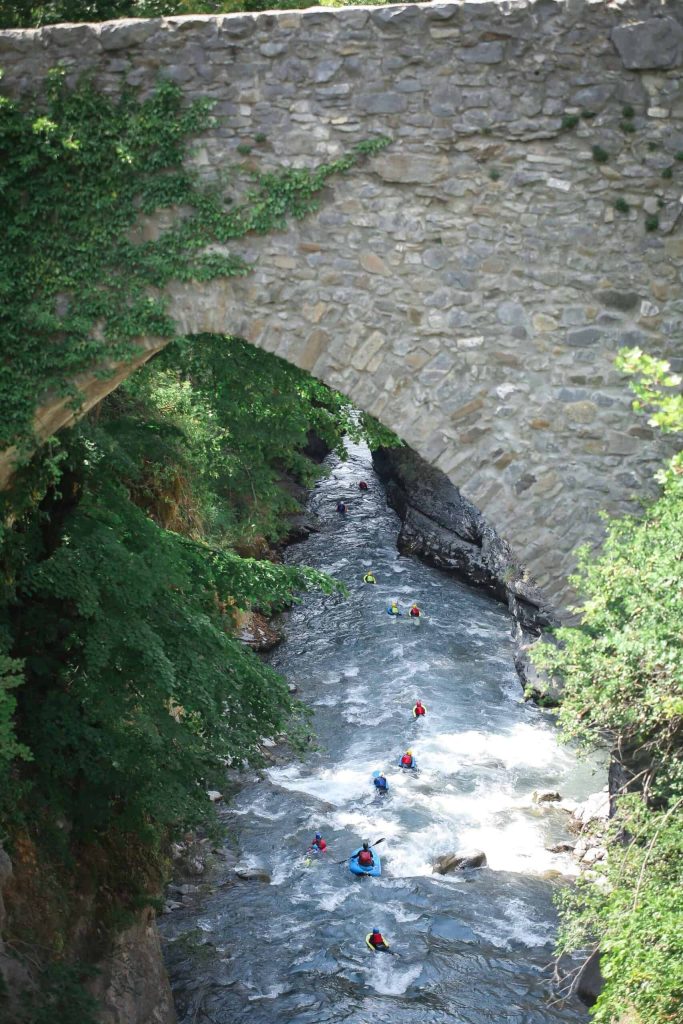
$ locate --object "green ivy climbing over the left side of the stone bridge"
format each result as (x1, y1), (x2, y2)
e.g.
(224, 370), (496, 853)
(0, 71), (388, 446)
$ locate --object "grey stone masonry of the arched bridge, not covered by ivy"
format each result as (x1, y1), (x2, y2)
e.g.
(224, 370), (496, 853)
(0, 0), (683, 602)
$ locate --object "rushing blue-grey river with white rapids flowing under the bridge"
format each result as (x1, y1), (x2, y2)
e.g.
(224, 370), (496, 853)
(162, 445), (603, 1024)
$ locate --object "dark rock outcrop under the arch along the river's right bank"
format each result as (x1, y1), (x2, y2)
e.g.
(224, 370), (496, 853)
(373, 447), (560, 705)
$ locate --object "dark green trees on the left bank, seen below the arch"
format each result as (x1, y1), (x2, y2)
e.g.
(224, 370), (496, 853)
(0, 336), (390, 1024)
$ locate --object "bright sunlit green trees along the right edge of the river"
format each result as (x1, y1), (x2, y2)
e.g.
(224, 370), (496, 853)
(536, 349), (683, 1024)
